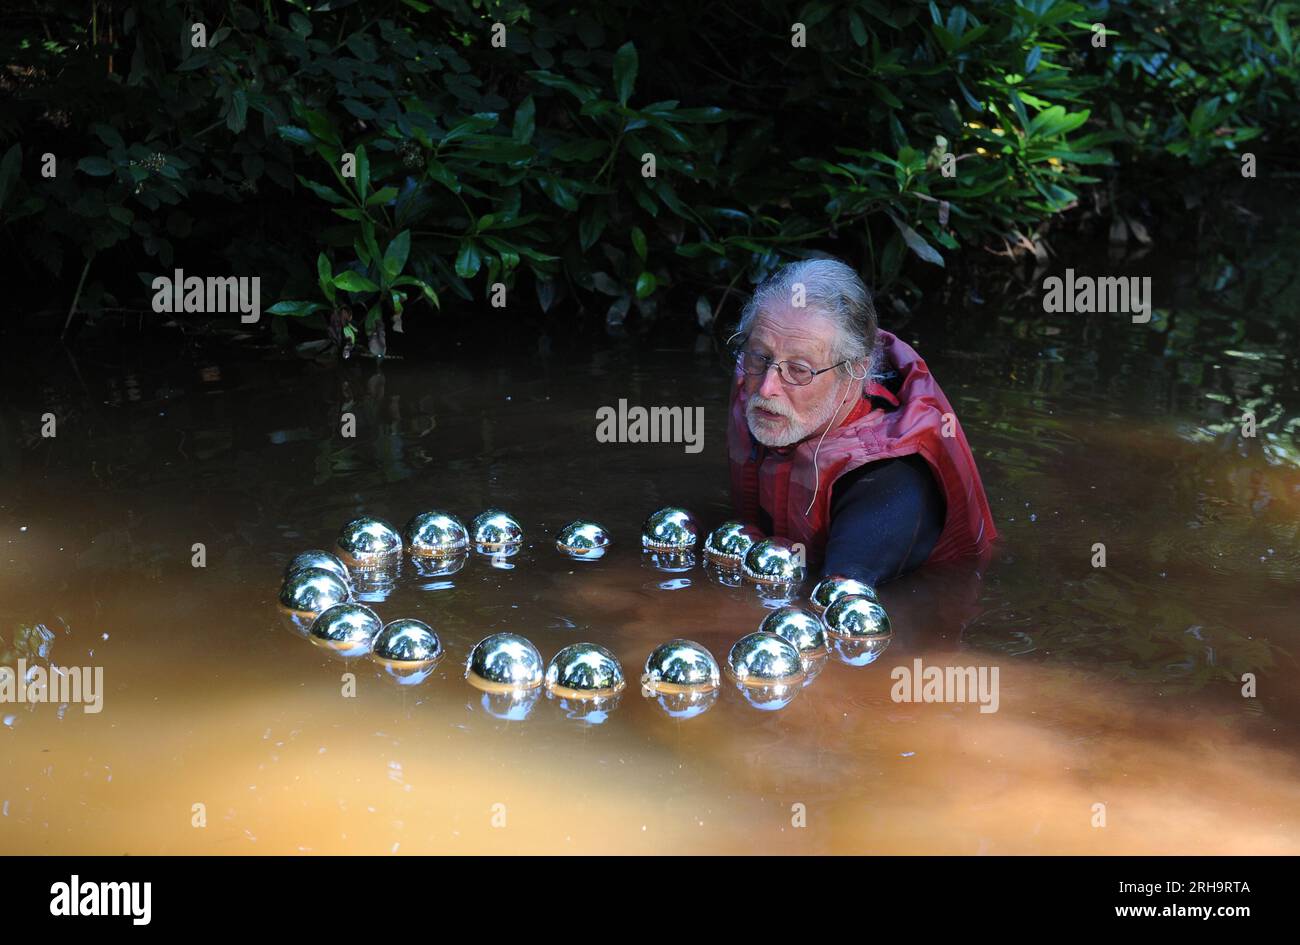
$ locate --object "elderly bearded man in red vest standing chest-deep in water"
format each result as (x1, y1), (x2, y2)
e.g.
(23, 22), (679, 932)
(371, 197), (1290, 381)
(727, 259), (997, 584)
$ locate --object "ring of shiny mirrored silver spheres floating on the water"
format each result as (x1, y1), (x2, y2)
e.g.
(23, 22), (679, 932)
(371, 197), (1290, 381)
(280, 507), (893, 718)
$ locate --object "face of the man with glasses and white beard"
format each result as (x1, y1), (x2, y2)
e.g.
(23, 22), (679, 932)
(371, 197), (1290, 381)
(742, 305), (852, 446)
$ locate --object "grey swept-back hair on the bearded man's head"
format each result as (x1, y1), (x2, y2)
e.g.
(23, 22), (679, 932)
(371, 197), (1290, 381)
(737, 256), (880, 377)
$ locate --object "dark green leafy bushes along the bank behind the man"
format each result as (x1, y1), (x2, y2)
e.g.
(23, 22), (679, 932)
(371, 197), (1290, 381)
(0, 0), (1300, 351)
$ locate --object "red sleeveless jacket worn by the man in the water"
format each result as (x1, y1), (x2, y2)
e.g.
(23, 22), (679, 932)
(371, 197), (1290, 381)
(727, 331), (997, 563)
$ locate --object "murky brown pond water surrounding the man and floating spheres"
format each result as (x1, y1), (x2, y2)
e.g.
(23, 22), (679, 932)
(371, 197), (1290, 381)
(0, 245), (1300, 854)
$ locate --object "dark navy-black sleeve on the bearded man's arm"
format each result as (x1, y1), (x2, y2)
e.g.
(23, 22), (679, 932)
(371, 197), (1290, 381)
(822, 454), (946, 585)
